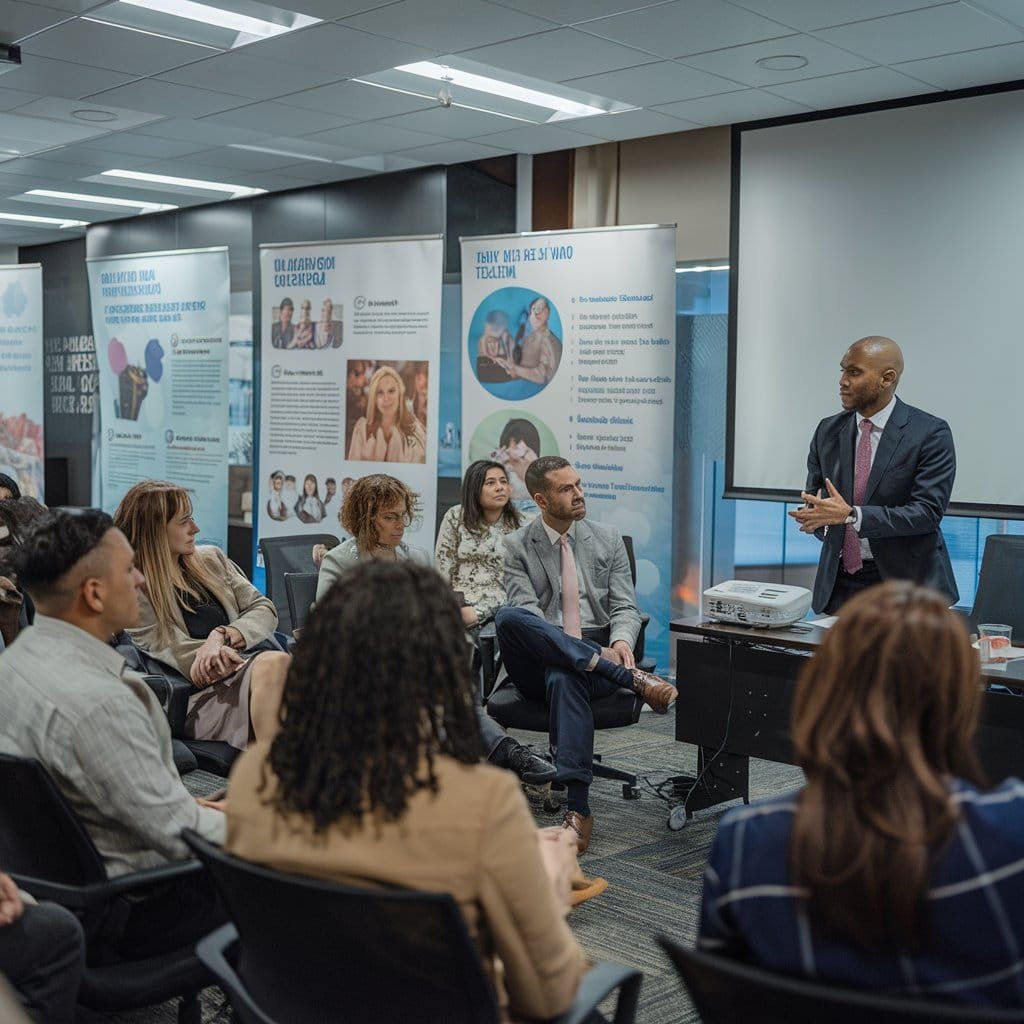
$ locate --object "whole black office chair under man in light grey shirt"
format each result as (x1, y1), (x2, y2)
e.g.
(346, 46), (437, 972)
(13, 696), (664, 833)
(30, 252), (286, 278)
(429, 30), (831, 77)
(0, 754), (214, 1024)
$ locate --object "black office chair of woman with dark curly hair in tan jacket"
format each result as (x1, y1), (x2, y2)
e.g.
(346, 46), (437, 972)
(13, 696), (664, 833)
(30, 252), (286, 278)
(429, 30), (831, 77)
(184, 831), (643, 1024)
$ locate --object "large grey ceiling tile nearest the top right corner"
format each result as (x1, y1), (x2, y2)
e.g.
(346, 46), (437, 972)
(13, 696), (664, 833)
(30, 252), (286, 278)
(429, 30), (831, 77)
(818, 3), (1024, 65)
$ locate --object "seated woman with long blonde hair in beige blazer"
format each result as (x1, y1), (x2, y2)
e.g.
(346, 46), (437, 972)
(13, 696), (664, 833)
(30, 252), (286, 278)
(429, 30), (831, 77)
(114, 480), (291, 750)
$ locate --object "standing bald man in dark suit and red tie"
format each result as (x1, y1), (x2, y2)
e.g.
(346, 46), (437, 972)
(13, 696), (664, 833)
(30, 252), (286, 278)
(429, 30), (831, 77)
(790, 336), (959, 614)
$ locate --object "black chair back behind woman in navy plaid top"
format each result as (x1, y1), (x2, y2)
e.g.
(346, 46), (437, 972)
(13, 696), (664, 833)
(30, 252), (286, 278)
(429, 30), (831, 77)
(657, 935), (1024, 1024)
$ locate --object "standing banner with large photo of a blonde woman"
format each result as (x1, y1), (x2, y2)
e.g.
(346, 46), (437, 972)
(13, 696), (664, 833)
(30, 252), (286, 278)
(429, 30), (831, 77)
(256, 236), (443, 552)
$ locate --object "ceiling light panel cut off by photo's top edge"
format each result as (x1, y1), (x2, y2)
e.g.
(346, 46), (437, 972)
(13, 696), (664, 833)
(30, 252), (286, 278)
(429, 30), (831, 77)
(83, 0), (321, 50)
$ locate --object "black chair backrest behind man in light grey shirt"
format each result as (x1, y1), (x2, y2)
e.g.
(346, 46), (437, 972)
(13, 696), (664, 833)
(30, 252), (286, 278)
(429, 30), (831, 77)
(0, 754), (106, 886)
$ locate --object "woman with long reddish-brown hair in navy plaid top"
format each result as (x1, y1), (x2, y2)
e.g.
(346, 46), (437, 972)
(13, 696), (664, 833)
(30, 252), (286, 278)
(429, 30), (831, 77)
(698, 581), (1024, 1007)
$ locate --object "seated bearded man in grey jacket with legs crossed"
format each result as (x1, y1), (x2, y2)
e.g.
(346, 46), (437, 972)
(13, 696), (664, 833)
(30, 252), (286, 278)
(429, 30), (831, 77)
(495, 456), (677, 853)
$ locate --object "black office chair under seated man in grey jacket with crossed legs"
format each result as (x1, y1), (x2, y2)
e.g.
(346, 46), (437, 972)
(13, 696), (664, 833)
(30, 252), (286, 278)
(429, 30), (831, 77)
(485, 537), (655, 800)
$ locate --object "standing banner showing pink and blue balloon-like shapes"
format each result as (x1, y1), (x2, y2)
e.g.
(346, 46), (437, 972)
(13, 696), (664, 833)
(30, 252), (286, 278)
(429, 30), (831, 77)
(86, 246), (230, 550)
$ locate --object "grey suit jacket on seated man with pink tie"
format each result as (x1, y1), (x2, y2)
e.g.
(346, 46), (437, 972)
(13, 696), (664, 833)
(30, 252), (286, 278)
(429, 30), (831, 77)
(505, 516), (640, 647)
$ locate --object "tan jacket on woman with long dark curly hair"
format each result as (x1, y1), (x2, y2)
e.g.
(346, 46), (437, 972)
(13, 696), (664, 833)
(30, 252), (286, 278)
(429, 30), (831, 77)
(225, 741), (586, 1019)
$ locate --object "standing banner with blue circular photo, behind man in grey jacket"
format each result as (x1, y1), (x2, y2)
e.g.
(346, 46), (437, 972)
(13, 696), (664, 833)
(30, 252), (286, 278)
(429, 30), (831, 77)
(462, 225), (676, 670)
